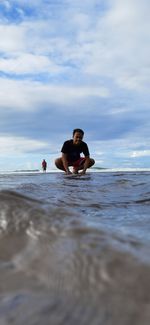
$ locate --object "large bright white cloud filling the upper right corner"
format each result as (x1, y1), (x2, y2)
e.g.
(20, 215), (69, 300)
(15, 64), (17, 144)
(82, 0), (150, 90)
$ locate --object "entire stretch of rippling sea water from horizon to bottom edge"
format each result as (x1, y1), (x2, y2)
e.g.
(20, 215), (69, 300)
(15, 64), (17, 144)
(0, 168), (150, 325)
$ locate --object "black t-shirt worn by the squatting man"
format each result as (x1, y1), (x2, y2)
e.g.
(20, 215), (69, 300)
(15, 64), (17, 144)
(61, 140), (90, 162)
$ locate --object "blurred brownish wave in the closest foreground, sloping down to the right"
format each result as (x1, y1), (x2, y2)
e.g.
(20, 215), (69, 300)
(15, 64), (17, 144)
(0, 190), (150, 325)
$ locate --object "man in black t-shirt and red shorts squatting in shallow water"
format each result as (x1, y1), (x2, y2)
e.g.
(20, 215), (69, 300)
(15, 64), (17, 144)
(55, 129), (95, 175)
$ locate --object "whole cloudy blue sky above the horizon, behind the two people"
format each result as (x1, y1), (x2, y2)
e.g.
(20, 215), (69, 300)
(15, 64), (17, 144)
(0, 0), (150, 170)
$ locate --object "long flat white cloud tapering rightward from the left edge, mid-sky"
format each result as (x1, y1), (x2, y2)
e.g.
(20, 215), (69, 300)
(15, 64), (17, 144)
(0, 79), (109, 111)
